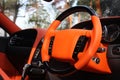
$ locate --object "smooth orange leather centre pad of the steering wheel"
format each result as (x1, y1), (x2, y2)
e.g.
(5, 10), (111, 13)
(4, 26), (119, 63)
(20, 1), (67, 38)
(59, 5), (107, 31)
(52, 29), (91, 63)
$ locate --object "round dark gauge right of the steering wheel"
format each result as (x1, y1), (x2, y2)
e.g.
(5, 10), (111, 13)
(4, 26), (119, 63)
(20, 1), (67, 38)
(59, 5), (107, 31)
(103, 24), (120, 42)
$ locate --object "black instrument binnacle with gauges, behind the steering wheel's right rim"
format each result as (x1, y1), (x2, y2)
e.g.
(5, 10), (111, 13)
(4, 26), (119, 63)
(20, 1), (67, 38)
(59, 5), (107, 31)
(72, 17), (120, 44)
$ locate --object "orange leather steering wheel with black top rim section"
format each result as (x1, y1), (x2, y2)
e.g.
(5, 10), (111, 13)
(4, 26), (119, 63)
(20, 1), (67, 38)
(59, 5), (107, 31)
(41, 5), (102, 74)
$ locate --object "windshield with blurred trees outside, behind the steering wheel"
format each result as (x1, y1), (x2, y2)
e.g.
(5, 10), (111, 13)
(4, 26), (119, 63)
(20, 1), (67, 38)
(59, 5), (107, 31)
(0, 0), (120, 29)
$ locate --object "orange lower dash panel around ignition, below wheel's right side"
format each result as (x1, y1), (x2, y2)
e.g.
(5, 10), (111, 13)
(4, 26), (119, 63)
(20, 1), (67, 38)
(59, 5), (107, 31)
(82, 44), (112, 74)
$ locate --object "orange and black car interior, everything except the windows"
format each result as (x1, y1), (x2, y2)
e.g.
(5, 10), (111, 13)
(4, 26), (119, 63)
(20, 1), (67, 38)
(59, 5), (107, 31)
(0, 5), (120, 80)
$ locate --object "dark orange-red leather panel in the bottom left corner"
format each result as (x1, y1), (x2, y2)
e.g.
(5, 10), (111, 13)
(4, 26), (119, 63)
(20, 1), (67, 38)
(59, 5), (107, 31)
(0, 52), (21, 80)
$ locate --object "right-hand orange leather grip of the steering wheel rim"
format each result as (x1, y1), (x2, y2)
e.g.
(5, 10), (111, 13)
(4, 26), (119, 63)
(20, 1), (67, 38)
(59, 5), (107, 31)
(74, 16), (102, 70)
